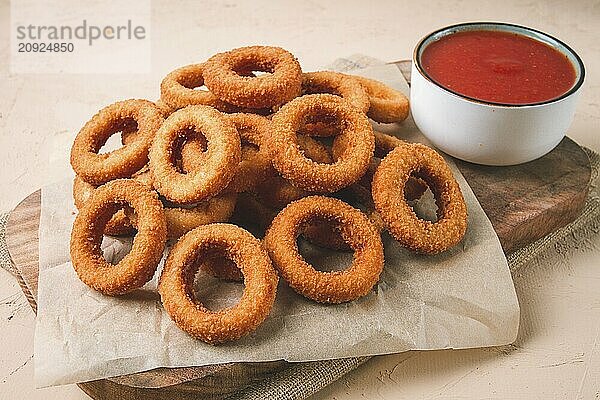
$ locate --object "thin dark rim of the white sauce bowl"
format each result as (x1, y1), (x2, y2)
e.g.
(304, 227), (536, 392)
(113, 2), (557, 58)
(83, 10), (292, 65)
(413, 21), (585, 108)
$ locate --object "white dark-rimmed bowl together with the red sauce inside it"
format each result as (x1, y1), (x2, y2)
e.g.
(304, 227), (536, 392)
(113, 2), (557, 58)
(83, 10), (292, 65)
(410, 22), (585, 166)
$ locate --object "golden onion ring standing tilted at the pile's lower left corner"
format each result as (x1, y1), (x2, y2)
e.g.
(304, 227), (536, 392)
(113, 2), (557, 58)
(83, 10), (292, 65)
(70, 179), (167, 295)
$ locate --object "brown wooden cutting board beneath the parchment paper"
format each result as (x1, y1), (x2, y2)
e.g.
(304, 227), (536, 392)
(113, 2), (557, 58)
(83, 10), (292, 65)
(6, 61), (591, 400)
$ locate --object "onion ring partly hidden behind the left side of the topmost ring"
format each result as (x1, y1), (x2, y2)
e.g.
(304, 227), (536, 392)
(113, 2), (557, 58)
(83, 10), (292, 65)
(160, 64), (244, 113)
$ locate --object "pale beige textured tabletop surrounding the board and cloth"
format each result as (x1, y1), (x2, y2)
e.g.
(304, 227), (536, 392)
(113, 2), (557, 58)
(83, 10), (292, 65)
(0, 0), (600, 400)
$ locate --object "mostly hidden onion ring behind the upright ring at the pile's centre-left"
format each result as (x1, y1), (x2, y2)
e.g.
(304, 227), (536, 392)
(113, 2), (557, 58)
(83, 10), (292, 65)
(181, 113), (273, 193)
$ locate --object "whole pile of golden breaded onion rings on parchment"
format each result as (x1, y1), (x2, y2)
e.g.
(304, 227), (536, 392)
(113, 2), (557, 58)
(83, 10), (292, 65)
(70, 46), (467, 344)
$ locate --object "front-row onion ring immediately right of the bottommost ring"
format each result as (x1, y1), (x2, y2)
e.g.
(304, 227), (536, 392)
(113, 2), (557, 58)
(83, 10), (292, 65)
(264, 196), (383, 303)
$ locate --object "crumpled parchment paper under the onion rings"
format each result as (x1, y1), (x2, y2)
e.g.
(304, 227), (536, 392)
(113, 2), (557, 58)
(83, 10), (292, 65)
(35, 65), (519, 387)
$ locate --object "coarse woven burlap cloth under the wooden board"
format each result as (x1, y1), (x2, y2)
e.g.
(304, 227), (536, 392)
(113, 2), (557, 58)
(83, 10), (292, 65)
(0, 148), (600, 400)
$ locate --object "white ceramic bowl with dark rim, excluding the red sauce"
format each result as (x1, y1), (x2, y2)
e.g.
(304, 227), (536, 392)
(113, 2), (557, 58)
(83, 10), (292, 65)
(410, 22), (585, 165)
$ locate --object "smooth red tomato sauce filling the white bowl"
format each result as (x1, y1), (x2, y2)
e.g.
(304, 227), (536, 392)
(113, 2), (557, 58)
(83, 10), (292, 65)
(421, 30), (576, 104)
